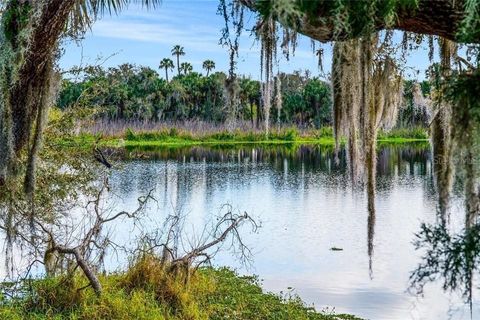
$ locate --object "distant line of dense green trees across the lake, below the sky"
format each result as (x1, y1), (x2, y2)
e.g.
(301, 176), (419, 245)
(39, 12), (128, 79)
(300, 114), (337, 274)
(58, 64), (429, 128)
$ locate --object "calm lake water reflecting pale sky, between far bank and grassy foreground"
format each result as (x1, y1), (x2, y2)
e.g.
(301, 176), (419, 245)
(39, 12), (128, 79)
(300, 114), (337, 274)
(110, 146), (480, 320)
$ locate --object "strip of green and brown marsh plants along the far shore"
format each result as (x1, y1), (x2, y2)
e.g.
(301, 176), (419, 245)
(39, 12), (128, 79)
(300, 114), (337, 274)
(62, 123), (429, 148)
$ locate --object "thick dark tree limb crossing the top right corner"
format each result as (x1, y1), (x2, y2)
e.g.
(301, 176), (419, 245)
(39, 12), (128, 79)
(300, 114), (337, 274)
(239, 0), (474, 43)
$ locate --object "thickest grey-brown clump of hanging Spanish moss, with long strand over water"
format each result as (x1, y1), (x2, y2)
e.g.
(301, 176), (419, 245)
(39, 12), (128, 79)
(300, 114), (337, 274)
(332, 34), (403, 275)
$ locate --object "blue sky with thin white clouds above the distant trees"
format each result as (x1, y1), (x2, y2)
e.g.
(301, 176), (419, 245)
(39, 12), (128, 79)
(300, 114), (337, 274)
(60, 0), (434, 79)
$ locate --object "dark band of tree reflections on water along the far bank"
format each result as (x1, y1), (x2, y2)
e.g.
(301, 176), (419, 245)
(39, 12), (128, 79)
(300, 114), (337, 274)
(117, 144), (430, 176)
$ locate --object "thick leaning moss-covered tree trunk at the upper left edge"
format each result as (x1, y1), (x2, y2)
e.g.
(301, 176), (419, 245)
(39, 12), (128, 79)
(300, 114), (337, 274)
(0, 0), (76, 184)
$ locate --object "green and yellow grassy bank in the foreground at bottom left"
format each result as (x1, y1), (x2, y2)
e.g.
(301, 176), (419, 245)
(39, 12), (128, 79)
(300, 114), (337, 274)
(0, 257), (361, 320)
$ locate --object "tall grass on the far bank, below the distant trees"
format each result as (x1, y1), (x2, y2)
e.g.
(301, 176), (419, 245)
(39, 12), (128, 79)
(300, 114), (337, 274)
(79, 120), (428, 145)
